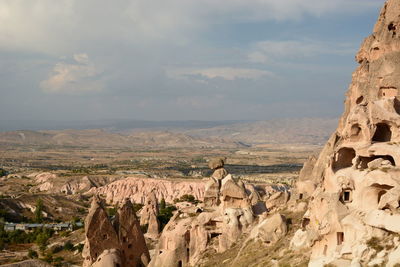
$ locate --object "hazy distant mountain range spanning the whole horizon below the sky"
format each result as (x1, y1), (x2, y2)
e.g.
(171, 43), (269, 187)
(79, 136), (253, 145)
(0, 118), (337, 147)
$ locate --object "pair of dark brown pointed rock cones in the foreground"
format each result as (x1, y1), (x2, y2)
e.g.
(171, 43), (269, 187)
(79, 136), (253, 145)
(82, 196), (150, 267)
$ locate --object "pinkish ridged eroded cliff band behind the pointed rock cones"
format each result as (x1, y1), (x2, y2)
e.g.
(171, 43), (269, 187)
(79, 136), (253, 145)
(87, 177), (204, 204)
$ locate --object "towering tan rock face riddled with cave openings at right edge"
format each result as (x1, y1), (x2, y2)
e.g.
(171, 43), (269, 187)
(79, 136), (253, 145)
(292, 0), (400, 266)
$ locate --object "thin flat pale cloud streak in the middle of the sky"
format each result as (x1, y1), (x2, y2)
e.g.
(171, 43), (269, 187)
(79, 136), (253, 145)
(167, 67), (274, 81)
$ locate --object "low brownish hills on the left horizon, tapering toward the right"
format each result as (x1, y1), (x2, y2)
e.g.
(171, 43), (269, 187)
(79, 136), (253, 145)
(0, 129), (242, 148)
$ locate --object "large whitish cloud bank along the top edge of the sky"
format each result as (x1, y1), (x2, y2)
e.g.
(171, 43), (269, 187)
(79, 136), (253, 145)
(0, 0), (383, 55)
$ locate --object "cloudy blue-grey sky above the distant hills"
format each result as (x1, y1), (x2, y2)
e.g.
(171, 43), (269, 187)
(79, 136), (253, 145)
(0, 0), (384, 121)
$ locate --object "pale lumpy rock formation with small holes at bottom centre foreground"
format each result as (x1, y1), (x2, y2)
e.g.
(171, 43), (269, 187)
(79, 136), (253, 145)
(149, 175), (260, 267)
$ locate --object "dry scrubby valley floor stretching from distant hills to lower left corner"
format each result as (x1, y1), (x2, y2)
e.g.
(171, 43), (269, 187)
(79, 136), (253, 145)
(0, 127), (321, 266)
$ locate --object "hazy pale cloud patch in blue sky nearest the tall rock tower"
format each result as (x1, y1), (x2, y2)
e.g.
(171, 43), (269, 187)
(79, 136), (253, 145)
(248, 40), (355, 63)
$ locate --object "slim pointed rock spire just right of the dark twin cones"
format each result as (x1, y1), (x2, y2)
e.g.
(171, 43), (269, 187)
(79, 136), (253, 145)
(140, 190), (160, 238)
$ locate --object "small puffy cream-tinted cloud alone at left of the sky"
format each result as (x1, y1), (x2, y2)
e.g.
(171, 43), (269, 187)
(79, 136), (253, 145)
(40, 53), (104, 94)
